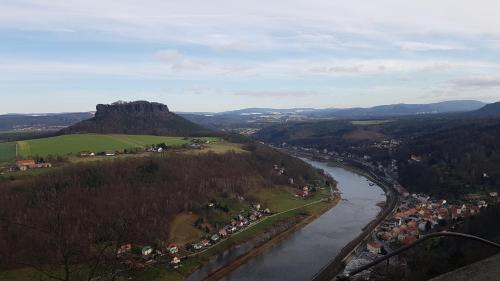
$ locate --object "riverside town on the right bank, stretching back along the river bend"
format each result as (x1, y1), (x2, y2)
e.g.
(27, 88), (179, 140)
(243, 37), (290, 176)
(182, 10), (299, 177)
(272, 142), (500, 280)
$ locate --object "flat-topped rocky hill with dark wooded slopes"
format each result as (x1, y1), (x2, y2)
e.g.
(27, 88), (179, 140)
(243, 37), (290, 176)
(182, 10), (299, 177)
(61, 101), (210, 136)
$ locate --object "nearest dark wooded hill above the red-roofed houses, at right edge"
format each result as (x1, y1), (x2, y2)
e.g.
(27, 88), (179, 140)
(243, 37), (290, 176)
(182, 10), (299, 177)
(396, 119), (500, 196)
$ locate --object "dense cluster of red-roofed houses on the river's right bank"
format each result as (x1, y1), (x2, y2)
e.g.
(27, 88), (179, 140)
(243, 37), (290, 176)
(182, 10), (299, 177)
(344, 184), (500, 280)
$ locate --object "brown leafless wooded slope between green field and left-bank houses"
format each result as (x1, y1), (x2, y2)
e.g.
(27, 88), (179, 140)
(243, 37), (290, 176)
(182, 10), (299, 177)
(0, 144), (322, 280)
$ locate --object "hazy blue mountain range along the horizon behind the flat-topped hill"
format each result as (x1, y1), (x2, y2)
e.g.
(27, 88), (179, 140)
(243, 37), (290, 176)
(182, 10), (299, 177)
(0, 100), (500, 131)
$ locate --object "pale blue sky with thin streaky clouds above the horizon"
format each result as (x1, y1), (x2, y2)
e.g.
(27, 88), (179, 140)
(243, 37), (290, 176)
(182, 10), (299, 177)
(0, 0), (500, 114)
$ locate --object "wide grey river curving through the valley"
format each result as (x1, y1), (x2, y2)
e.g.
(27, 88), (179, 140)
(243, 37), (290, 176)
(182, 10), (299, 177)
(188, 159), (386, 281)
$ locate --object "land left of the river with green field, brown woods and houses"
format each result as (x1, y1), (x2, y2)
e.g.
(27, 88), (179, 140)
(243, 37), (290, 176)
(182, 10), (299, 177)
(0, 100), (339, 281)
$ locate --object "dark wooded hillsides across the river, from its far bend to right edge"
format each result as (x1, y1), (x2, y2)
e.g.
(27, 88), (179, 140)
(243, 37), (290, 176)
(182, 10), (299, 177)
(256, 116), (500, 196)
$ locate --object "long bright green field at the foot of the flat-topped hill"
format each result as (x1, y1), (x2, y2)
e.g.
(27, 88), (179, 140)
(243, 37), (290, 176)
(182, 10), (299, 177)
(14, 134), (218, 158)
